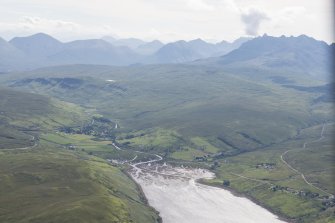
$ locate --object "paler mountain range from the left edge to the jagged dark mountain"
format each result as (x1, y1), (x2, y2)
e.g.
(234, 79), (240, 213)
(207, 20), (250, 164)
(0, 33), (249, 72)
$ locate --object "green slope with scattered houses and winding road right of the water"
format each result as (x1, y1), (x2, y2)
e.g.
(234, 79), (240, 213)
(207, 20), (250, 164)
(207, 125), (335, 222)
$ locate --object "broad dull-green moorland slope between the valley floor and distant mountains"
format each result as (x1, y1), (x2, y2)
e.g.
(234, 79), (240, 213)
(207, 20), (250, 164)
(2, 65), (332, 150)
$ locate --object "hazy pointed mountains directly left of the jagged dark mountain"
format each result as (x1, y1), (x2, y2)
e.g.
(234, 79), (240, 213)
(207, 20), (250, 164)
(149, 38), (249, 63)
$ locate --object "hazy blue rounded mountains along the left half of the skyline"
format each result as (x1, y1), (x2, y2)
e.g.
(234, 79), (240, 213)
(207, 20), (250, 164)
(0, 33), (146, 69)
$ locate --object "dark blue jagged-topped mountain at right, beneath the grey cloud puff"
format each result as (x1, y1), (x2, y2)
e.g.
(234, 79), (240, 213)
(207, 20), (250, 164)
(216, 35), (333, 79)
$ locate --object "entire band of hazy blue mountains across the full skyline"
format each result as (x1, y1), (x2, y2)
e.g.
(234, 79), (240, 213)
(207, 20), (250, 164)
(0, 33), (335, 79)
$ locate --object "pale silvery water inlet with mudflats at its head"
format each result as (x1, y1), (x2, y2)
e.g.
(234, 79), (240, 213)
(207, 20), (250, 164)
(131, 164), (284, 223)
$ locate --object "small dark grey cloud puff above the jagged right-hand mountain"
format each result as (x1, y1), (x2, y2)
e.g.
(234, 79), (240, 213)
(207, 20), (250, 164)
(241, 8), (270, 36)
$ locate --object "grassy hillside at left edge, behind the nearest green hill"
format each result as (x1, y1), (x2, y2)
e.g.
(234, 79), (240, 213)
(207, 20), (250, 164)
(0, 89), (88, 149)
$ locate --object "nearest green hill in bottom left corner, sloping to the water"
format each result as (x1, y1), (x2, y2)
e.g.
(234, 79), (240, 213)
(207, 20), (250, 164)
(0, 145), (157, 222)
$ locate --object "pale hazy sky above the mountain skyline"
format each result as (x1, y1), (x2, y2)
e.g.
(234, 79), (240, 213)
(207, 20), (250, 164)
(0, 0), (334, 42)
